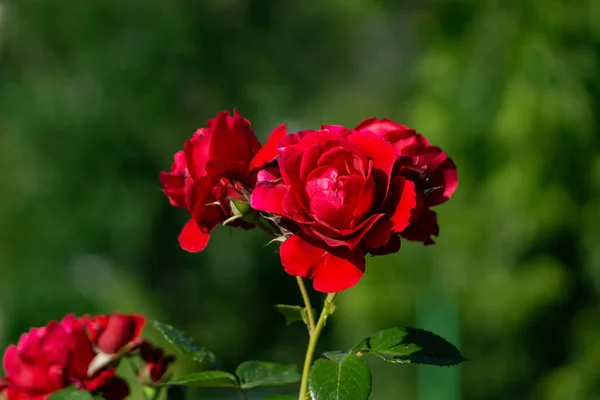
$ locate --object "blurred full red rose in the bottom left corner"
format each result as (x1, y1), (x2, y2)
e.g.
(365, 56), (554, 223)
(1, 315), (129, 400)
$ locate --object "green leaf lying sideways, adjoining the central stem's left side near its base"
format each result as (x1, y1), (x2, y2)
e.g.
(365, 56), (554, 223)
(235, 361), (300, 389)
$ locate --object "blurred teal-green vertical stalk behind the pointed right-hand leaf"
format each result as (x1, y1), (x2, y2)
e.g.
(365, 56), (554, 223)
(416, 283), (461, 400)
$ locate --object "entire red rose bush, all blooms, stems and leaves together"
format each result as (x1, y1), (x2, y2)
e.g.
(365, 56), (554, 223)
(0, 111), (466, 400)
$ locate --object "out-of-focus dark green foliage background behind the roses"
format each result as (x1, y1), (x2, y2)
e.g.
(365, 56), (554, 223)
(0, 0), (600, 400)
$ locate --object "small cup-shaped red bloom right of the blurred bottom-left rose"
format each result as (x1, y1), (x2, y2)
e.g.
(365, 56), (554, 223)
(85, 313), (146, 354)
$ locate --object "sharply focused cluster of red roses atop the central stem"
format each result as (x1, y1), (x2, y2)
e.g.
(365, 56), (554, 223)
(160, 111), (458, 292)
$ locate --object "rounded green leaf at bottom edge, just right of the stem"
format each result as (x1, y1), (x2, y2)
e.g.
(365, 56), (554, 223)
(308, 354), (371, 400)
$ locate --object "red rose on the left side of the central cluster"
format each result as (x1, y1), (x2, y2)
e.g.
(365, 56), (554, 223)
(159, 111), (260, 252)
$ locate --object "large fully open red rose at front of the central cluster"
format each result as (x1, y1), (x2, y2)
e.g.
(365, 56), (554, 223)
(251, 126), (417, 292)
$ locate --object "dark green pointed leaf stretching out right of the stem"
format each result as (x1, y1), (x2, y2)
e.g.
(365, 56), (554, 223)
(351, 328), (466, 366)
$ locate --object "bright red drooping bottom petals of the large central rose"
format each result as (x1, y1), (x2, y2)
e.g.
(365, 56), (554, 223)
(280, 235), (365, 293)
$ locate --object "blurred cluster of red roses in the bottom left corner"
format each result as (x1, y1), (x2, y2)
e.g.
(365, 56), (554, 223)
(0, 313), (174, 400)
